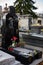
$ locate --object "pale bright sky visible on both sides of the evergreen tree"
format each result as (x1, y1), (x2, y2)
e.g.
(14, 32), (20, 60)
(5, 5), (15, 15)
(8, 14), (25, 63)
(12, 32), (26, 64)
(0, 0), (43, 13)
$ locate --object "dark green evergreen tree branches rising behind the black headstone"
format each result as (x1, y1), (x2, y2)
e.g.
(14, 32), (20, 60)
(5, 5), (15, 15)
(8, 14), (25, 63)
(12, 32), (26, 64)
(14, 0), (37, 17)
